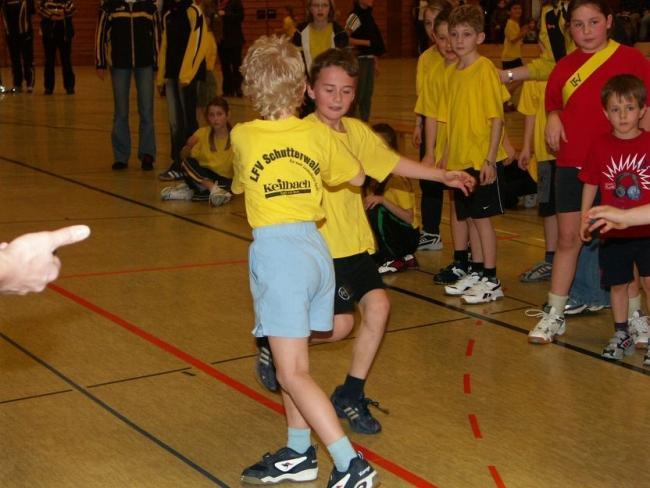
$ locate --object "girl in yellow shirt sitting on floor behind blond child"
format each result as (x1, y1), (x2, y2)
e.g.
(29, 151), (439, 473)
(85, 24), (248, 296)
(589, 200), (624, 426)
(160, 97), (233, 207)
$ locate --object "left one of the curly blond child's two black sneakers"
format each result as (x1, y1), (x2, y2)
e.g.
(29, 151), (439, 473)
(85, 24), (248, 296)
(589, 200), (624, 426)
(241, 446), (318, 486)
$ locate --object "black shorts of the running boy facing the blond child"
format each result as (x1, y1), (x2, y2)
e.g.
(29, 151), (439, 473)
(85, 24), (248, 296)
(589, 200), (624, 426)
(334, 252), (386, 314)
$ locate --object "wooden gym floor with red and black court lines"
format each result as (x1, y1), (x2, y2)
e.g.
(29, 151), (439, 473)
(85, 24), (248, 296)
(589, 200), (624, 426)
(0, 60), (650, 488)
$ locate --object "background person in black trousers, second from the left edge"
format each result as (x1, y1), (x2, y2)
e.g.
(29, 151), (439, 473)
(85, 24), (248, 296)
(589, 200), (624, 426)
(38, 0), (76, 95)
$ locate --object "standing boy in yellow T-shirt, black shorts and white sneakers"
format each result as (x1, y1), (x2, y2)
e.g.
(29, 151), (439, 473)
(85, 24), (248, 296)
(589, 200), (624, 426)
(438, 5), (509, 303)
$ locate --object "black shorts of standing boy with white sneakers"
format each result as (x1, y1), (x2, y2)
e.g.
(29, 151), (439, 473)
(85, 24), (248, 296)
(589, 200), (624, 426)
(453, 162), (503, 220)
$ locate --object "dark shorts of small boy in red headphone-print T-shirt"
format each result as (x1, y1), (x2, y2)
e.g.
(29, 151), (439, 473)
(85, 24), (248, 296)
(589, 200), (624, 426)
(598, 237), (650, 287)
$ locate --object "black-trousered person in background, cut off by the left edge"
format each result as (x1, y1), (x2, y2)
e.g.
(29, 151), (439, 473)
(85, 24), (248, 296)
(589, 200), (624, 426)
(0, 0), (34, 93)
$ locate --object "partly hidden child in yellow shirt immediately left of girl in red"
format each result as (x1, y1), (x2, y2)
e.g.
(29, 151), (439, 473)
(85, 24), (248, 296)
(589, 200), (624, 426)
(517, 81), (557, 283)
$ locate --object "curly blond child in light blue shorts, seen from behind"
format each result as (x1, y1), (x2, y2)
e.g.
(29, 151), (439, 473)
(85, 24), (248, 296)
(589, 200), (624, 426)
(231, 36), (377, 487)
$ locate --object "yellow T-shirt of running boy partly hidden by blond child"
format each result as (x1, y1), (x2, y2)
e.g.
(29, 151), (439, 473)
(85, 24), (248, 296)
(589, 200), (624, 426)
(305, 114), (400, 258)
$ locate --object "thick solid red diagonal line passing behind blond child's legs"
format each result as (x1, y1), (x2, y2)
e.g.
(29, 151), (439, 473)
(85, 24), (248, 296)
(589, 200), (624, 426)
(48, 283), (436, 488)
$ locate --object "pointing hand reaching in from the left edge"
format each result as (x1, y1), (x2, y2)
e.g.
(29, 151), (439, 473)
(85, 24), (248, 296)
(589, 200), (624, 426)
(0, 225), (90, 295)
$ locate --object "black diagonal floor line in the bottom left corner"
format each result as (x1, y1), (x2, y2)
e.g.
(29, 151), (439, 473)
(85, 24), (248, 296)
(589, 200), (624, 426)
(0, 332), (230, 488)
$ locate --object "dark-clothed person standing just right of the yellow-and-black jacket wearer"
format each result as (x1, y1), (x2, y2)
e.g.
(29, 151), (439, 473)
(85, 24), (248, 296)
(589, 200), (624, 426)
(217, 0), (244, 97)
